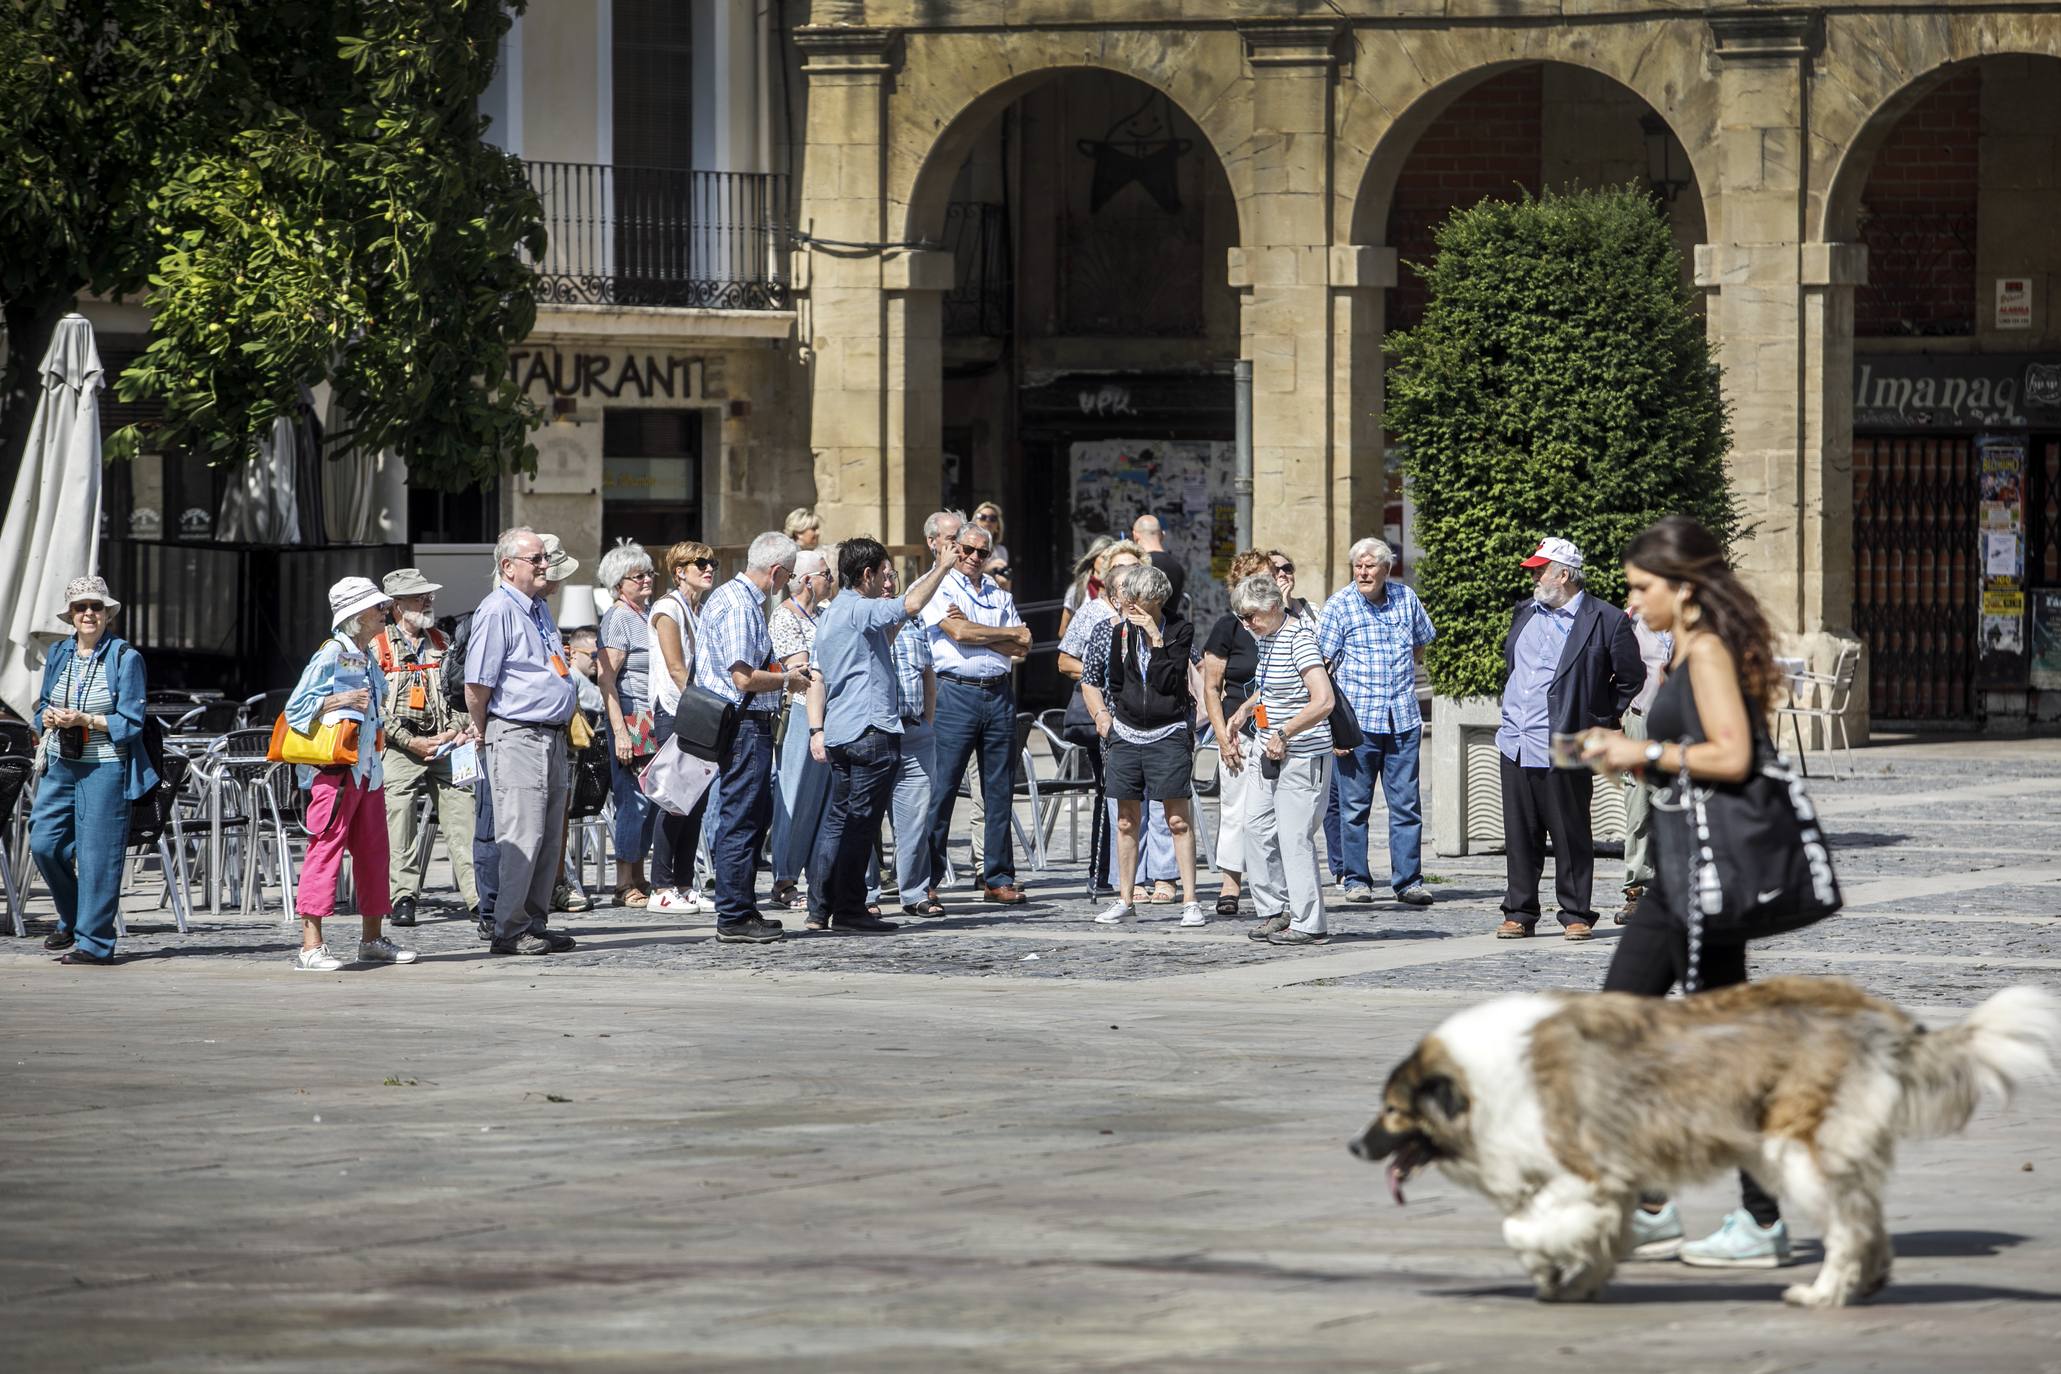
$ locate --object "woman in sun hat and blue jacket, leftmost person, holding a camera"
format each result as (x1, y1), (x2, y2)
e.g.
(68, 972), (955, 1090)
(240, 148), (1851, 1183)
(29, 577), (157, 964)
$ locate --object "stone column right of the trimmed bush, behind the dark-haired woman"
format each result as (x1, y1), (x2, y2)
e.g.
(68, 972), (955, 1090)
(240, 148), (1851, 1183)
(1696, 10), (1865, 733)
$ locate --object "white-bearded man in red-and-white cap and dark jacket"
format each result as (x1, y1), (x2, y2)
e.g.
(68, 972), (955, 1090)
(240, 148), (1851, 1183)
(1496, 540), (1647, 939)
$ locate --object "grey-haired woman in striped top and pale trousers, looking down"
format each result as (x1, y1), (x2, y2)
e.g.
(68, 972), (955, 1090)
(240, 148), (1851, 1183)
(1230, 573), (1331, 946)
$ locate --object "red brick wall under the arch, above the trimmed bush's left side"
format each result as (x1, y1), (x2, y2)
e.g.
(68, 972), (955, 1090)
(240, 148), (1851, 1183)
(1389, 66), (1549, 330)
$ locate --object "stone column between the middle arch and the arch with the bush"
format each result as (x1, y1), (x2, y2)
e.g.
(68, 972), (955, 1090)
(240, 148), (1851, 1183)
(1230, 23), (1352, 599)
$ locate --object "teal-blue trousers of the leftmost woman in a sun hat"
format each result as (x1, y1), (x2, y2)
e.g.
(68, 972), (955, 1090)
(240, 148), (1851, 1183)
(29, 746), (129, 958)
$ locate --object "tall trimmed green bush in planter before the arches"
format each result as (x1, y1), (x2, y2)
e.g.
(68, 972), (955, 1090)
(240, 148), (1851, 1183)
(1387, 190), (1739, 696)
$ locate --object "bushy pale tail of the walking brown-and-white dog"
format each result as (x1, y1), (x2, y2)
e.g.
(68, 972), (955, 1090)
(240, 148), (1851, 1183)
(1896, 987), (2061, 1135)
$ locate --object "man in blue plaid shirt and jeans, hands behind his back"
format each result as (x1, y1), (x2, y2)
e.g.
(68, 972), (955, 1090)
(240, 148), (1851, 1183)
(1317, 540), (1439, 906)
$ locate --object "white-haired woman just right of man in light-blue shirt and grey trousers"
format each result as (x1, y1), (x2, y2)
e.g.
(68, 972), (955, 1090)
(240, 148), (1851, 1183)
(594, 540), (657, 906)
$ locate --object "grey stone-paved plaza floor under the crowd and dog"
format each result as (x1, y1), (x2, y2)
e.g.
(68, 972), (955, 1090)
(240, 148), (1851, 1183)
(0, 742), (2061, 1372)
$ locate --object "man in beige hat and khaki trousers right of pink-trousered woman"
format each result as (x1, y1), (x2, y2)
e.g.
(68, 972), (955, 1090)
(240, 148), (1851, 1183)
(373, 569), (480, 925)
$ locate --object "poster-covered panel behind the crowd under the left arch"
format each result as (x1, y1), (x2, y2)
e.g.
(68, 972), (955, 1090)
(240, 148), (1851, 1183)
(1070, 439), (1237, 630)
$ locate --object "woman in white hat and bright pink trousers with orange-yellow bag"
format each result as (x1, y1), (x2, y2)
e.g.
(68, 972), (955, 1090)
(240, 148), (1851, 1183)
(286, 577), (416, 972)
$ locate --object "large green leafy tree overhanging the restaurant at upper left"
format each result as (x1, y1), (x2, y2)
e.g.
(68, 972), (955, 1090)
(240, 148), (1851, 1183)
(0, 0), (544, 490)
